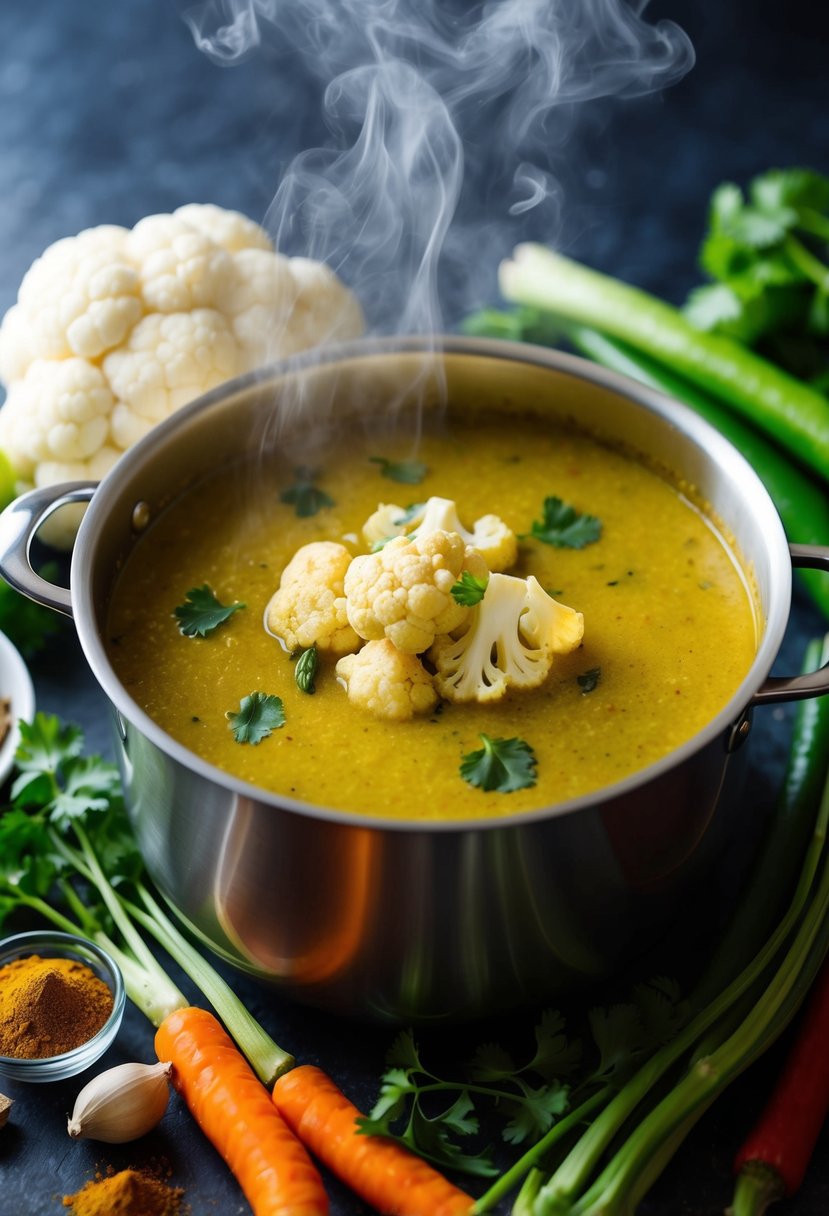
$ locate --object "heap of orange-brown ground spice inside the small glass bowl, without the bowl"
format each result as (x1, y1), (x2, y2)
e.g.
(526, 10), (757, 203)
(0, 955), (113, 1059)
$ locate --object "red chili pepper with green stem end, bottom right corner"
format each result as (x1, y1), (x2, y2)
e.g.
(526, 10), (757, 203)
(732, 961), (829, 1216)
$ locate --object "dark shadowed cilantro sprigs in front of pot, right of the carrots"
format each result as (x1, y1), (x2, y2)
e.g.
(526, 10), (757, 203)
(359, 978), (688, 1186)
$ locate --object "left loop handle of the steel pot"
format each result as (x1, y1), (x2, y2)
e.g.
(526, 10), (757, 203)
(0, 482), (97, 617)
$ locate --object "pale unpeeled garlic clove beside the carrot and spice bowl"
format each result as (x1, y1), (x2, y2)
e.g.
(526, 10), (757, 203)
(67, 1063), (173, 1144)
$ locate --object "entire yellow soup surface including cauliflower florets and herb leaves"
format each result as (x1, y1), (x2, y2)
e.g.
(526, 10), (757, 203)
(108, 415), (757, 820)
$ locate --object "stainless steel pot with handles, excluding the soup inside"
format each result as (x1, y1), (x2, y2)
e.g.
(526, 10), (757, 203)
(0, 338), (829, 1020)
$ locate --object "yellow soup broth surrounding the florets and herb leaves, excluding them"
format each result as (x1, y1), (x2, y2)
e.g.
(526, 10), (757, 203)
(108, 416), (757, 820)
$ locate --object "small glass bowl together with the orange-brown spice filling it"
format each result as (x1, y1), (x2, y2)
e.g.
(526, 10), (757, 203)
(0, 931), (125, 1081)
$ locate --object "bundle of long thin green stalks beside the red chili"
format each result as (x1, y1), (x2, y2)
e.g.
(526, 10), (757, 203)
(514, 640), (829, 1216)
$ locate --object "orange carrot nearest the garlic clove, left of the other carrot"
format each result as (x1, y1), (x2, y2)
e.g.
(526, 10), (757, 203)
(156, 1007), (328, 1216)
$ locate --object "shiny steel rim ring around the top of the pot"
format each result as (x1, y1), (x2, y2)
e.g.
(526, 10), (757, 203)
(71, 334), (791, 834)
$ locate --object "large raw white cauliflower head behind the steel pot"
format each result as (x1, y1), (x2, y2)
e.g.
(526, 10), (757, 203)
(0, 203), (363, 544)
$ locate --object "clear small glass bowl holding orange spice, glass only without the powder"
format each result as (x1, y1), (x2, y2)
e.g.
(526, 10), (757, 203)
(0, 929), (126, 1081)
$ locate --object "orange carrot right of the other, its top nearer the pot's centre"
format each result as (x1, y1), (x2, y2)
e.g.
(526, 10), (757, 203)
(272, 1064), (474, 1216)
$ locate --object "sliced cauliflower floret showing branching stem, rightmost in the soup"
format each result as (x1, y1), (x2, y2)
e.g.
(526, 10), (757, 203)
(429, 574), (585, 702)
